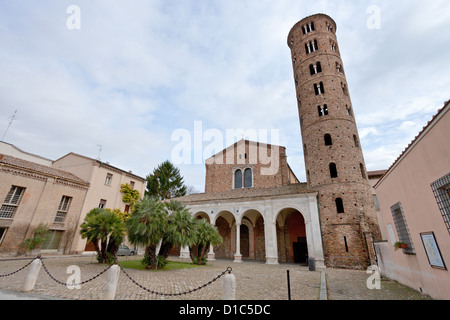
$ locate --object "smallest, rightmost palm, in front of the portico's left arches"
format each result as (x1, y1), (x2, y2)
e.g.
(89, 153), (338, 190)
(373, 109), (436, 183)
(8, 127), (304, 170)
(189, 219), (222, 264)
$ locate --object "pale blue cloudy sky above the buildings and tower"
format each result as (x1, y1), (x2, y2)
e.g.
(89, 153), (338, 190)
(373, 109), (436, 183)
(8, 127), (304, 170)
(0, 0), (450, 191)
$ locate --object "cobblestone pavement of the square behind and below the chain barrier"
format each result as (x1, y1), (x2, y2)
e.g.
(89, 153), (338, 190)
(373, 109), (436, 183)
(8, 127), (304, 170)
(0, 256), (428, 300)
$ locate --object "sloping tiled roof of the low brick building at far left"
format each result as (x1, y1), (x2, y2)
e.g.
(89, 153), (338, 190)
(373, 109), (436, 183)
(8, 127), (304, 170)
(0, 154), (89, 185)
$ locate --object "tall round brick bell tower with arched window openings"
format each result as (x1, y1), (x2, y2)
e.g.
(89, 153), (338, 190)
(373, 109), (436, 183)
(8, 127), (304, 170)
(288, 14), (380, 268)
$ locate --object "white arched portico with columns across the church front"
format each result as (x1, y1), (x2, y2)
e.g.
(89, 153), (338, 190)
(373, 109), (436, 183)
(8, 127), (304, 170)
(181, 193), (324, 267)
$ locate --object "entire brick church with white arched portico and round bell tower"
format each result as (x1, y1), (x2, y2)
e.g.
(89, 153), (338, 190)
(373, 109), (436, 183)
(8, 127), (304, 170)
(178, 14), (380, 268)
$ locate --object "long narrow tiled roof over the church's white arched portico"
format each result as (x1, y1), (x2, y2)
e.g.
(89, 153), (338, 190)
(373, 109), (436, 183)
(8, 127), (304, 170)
(174, 183), (316, 205)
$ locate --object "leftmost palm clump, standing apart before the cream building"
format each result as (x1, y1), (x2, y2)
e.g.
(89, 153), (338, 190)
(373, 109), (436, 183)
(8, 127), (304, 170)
(80, 208), (126, 263)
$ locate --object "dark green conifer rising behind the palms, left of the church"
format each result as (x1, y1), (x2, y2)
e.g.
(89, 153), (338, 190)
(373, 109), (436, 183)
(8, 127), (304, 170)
(145, 160), (186, 200)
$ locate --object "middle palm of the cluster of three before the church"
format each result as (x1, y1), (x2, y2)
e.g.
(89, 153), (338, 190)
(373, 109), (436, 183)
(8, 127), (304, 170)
(160, 200), (196, 259)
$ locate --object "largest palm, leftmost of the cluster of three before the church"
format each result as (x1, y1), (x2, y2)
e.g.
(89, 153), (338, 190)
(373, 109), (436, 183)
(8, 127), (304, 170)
(126, 196), (169, 269)
